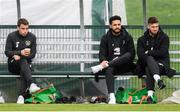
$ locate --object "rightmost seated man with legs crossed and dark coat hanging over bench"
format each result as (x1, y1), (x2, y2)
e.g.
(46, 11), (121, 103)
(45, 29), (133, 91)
(137, 17), (175, 103)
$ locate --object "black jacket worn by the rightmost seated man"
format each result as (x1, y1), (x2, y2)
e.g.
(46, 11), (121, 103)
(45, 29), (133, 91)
(137, 28), (174, 77)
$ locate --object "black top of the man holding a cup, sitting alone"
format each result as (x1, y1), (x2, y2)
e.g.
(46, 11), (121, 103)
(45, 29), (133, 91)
(5, 31), (36, 62)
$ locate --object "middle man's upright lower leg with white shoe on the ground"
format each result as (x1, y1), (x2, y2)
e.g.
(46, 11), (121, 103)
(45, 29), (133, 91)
(105, 67), (116, 104)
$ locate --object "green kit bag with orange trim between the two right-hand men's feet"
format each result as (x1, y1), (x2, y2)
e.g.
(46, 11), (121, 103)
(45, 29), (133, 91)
(115, 87), (157, 104)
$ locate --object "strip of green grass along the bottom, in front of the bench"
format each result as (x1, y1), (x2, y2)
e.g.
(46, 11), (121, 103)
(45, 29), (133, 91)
(0, 104), (180, 112)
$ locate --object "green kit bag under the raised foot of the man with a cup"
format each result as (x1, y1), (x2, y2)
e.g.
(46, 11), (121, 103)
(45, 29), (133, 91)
(25, 84), (63, 104)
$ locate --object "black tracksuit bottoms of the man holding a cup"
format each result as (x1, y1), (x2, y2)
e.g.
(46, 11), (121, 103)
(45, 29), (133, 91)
(8, 59), (32, 95)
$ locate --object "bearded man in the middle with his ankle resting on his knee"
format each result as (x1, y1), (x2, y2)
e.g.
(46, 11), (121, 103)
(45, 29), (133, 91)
(91, 16), (135, 104)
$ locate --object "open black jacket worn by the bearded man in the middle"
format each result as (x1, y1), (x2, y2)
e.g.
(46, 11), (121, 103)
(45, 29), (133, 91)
(99, 26), (135, 62)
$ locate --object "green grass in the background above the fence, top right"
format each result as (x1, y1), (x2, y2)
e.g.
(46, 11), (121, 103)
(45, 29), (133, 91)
(125, 0), (180, 25)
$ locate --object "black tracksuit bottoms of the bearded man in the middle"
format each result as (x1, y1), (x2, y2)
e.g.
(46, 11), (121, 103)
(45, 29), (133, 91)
(105, 53), (132, 93)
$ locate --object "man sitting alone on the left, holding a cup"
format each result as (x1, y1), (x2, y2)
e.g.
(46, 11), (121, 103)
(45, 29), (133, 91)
(5, 18), (40, 104)
